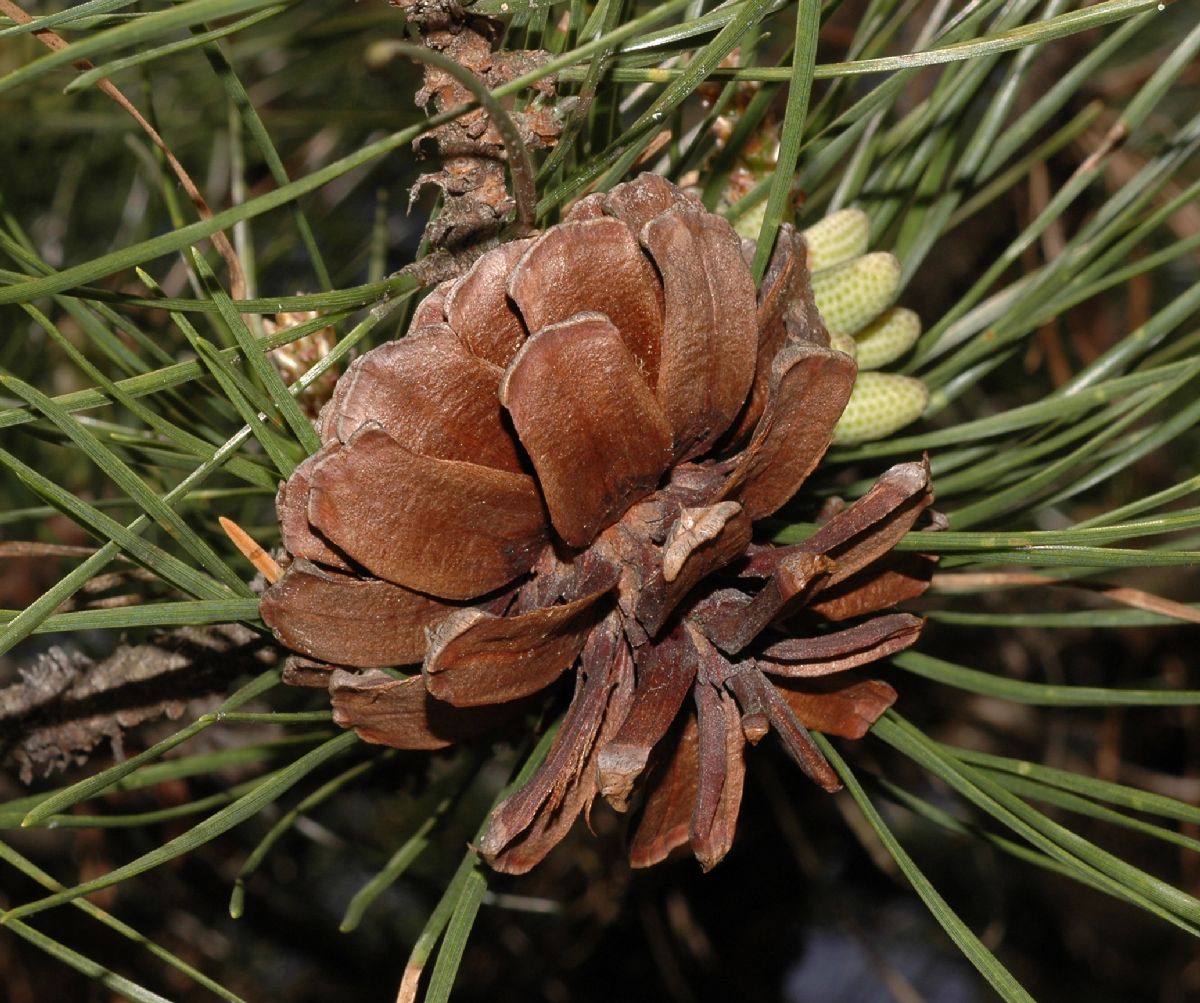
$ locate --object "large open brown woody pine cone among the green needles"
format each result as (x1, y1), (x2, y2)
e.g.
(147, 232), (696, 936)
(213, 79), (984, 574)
(262, 175), (932, 872)
